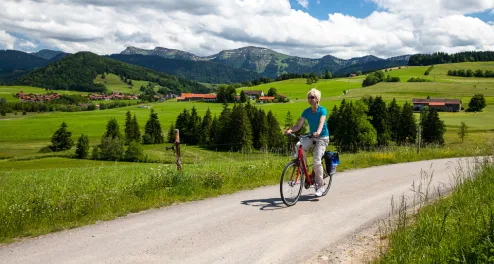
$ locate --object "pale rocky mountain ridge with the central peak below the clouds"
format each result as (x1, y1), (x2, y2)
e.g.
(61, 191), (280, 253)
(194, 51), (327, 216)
(121, 46), (409, 78)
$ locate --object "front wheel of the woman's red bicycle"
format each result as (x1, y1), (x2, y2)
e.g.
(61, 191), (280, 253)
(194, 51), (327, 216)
(280, 161), (304, 206)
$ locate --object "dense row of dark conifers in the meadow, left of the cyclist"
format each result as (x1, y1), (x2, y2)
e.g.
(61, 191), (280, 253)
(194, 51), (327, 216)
(167, 102), (285, 152)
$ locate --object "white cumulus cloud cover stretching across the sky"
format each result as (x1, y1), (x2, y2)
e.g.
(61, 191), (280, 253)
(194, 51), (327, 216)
(0, 0), (494, 59)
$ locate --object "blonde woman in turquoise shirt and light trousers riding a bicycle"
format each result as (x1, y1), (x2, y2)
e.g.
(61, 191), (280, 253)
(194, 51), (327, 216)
(285, 88), (329, 196)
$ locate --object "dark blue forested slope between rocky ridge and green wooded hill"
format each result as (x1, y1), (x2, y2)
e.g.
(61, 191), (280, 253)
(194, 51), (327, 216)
(108, 54), (263, 83)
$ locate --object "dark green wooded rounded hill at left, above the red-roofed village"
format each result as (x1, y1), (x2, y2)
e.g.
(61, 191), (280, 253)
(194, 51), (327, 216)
(15, 52), (209, 93)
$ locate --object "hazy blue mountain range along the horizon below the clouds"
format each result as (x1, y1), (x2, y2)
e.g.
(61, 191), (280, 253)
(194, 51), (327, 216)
(0, 46), (410, 83)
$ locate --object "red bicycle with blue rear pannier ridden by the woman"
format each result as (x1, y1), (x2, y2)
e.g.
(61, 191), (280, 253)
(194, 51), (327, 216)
(280, 134), (339, 206)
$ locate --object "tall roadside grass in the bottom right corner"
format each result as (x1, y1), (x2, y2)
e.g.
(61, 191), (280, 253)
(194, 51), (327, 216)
(373, 160), (494, 263)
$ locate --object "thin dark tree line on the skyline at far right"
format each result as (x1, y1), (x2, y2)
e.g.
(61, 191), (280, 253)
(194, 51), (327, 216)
(408, 51), (494, 66)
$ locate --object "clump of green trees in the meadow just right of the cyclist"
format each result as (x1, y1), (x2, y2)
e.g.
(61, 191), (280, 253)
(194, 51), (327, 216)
(328, 96), (446, 152)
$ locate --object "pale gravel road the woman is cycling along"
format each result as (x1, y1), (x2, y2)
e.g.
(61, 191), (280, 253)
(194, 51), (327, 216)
(0, 159), (478, 263)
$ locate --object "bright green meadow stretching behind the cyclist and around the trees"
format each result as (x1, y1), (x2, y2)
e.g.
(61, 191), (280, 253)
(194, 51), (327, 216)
(0, 60), (494, 241)
